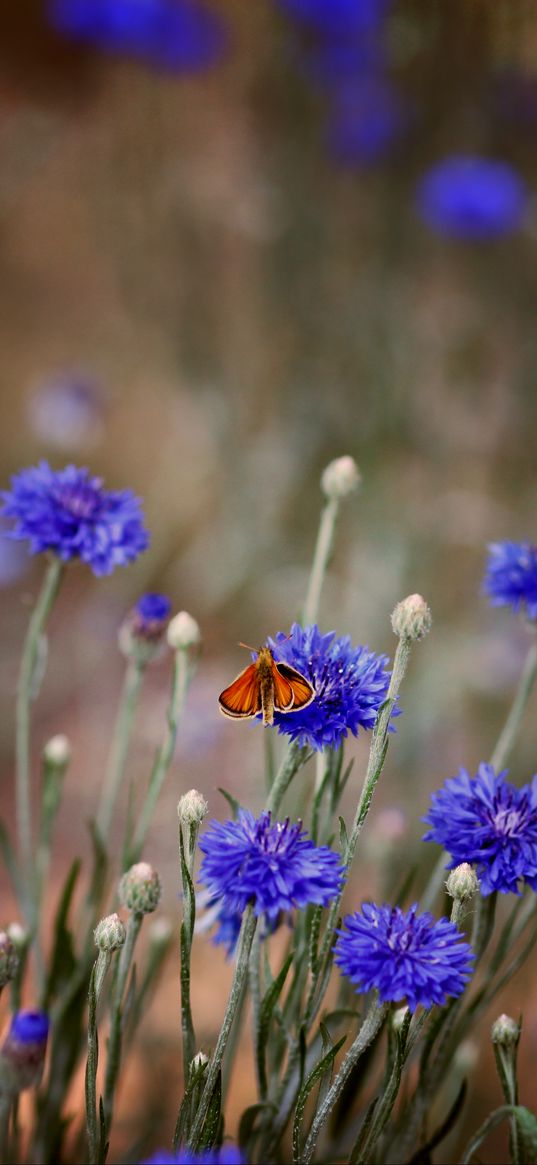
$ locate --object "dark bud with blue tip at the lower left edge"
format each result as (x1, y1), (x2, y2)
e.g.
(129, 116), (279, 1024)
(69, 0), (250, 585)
(0, 1011), (49, 1096)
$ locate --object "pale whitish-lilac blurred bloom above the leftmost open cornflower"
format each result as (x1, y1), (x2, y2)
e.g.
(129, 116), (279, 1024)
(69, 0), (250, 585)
(28, 373), (103, 450)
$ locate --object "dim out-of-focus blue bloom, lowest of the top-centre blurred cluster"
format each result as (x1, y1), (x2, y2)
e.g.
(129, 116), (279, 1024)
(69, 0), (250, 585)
(326, 75), (410, 165)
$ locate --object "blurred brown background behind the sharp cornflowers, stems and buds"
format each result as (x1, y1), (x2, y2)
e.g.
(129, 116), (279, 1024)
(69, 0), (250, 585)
(0, 0), (537, 1162)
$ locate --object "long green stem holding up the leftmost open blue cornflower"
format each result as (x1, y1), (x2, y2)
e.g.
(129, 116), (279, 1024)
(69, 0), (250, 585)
(16, 557), (64, 930)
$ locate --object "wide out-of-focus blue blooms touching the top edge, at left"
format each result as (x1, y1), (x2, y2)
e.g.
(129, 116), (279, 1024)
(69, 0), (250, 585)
(48, 0), (227, 72)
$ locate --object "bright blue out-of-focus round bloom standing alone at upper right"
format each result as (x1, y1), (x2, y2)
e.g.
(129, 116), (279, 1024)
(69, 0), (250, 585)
(416, 155), (528, 240)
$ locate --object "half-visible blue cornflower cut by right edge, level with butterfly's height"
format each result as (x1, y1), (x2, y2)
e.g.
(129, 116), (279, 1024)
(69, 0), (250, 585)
(483, 542), (537, 619)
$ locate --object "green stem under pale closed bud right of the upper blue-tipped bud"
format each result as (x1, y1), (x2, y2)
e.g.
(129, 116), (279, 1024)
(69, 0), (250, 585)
(123, 651), (193, 869)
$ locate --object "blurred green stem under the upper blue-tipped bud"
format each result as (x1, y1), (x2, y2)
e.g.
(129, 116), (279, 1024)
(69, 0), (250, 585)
(97, 659), (146, 847)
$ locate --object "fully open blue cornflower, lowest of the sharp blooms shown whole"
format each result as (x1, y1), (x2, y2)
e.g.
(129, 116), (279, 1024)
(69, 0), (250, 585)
(334, 903), (475, 1011)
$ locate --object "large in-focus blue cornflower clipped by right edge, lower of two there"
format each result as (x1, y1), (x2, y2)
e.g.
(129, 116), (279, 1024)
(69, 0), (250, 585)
(423, 764), (537, 895)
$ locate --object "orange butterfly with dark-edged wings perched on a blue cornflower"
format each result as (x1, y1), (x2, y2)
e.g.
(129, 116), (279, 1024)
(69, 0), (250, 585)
(218, 643), (316, 725)
